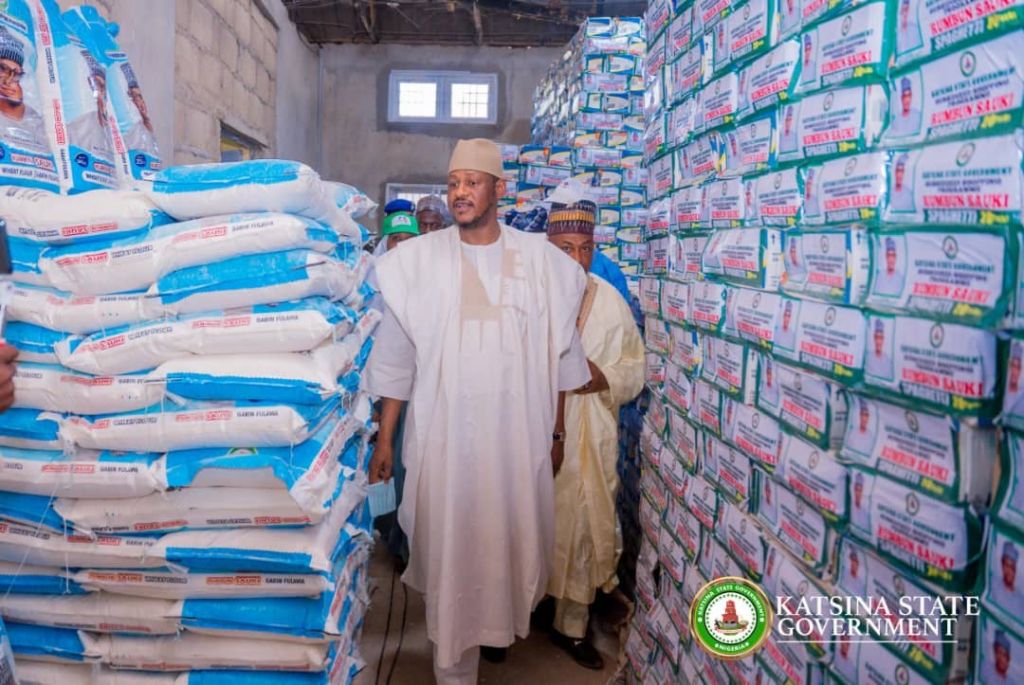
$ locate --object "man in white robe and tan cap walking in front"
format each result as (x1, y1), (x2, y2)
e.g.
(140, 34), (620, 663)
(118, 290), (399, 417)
(365, 139), (590, 685)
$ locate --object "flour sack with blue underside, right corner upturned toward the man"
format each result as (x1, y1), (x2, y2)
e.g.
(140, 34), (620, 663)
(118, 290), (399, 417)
(151, 309), (380, 403)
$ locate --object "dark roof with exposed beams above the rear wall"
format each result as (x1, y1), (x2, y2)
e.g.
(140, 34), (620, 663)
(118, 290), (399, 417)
(284, 0), (647, 47)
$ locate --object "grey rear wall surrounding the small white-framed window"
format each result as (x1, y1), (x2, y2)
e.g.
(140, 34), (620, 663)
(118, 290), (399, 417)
(322, 44), (562, 198)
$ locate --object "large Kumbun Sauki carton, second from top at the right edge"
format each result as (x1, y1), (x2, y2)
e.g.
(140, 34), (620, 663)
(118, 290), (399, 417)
(882, 30), (1024, 145)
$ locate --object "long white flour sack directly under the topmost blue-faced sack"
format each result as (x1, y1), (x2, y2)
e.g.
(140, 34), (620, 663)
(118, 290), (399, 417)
(39, 214), (339, 295)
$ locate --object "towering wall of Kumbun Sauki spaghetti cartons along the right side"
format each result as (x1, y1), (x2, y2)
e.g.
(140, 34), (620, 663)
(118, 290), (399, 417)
(626, 0), (1024, 684)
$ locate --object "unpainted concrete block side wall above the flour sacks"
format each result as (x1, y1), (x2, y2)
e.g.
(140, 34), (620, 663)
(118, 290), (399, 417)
(60, 0), (319, 166)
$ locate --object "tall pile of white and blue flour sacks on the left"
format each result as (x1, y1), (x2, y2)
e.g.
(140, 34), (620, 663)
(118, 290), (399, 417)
(0, 161), (380, 684)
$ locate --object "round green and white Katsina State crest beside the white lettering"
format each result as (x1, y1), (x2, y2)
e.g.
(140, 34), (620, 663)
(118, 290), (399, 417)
(690, 576), (772, 659)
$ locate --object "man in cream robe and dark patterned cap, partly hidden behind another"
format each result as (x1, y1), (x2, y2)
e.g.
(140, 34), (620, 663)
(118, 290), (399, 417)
(548, 201), (644, 671)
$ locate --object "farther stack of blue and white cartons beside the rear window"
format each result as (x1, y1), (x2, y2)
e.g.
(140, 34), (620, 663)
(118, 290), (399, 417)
(532, 17), (646, 286)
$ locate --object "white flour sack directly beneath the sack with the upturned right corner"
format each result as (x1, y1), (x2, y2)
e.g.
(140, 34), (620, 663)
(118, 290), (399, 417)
(60, 398), (338, 452)
